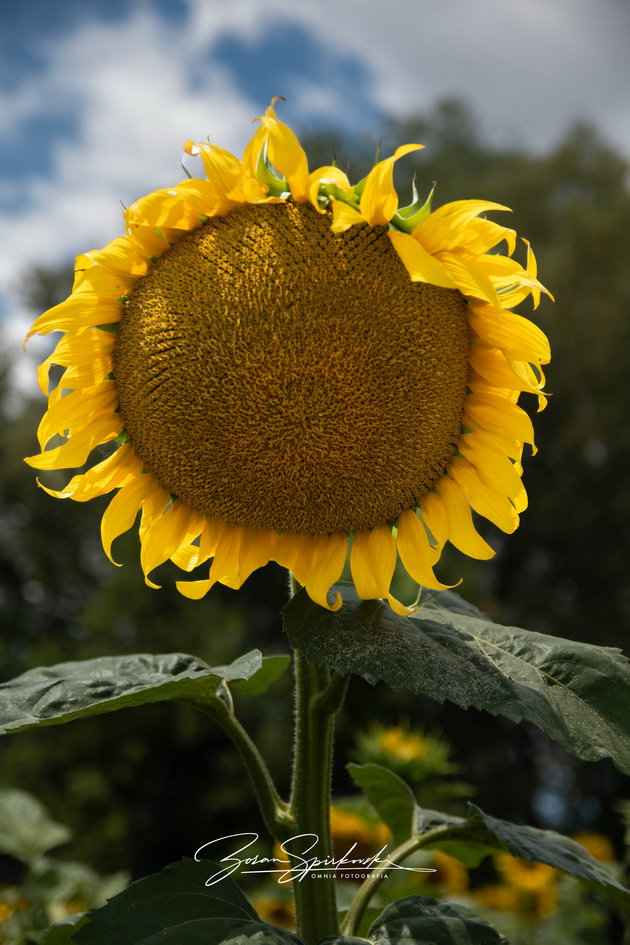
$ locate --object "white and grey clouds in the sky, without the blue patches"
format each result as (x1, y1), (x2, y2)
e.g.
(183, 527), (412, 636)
(0, 0), (630, 394)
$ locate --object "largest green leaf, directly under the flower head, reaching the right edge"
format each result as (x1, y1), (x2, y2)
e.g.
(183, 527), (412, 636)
(283, 585), (630, 774)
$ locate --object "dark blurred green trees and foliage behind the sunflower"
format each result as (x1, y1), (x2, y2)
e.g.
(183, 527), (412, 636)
(0, 102), (630, 928)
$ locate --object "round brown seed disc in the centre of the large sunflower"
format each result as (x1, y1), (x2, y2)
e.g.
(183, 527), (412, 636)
(114, 202), (469, 535)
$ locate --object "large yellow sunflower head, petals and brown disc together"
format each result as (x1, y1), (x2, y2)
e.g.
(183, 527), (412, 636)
(26, 100), (549, 614)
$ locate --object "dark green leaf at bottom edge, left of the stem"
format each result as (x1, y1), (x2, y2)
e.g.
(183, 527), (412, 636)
(73, 860), (303, 945)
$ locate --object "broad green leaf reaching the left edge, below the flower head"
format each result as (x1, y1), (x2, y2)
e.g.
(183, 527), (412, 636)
(0, 650), (274, 734)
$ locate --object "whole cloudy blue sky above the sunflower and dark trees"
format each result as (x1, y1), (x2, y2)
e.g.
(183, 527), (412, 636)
(0, 0), (630, 388)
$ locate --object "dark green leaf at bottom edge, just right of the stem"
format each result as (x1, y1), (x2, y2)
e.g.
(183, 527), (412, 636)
(320, 896), (509, 945)
